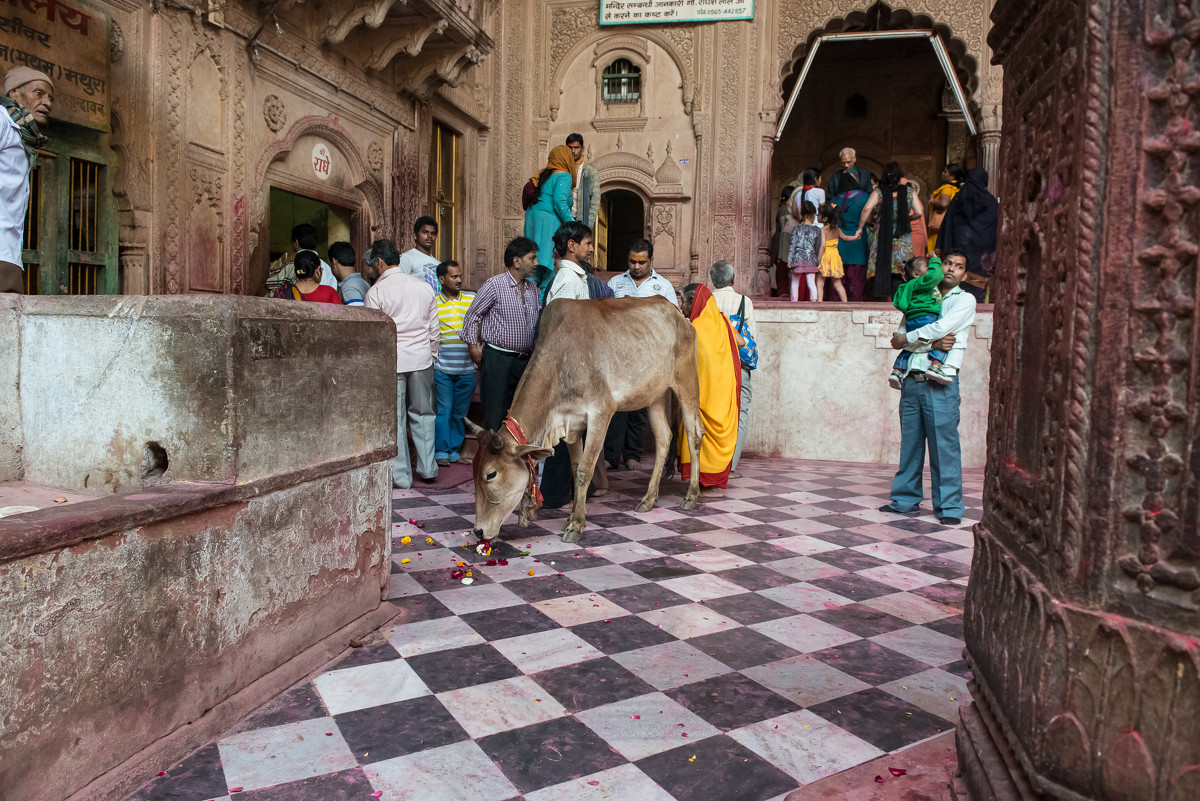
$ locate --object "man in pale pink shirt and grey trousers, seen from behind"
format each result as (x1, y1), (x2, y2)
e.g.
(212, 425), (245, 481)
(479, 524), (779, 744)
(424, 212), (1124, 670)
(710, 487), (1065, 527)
(364, 239), (442, 489)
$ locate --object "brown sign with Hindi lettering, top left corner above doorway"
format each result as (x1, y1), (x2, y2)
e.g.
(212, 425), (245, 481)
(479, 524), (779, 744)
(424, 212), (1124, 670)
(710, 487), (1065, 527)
(0, 0), (109, 131)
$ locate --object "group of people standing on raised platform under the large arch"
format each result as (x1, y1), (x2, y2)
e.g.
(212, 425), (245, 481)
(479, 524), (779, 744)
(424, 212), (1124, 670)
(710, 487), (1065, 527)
(772, 147), (998, 301)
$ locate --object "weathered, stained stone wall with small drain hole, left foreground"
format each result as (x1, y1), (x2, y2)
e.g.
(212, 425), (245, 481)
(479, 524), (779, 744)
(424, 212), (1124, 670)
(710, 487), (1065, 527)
(0, 295), (396, 801)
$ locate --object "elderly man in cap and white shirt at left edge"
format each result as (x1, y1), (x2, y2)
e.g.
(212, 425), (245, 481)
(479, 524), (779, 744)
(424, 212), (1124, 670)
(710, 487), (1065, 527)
(0, 67), (54, 294)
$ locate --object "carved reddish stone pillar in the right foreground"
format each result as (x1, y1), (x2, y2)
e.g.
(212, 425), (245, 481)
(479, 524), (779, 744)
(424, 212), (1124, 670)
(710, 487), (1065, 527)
(958, 0), (1200, 801)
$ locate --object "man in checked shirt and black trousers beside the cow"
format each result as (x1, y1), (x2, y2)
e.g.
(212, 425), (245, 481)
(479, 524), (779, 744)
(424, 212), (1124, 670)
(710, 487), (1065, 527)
(460, 236), (541, 432)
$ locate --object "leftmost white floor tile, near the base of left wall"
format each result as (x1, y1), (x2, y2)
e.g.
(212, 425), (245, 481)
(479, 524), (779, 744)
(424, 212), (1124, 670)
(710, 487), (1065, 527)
(217, 717), (358, 790)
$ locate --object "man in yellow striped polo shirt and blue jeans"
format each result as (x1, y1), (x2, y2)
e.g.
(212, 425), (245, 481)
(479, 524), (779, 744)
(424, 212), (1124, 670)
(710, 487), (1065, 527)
(433, 261), (475, 466)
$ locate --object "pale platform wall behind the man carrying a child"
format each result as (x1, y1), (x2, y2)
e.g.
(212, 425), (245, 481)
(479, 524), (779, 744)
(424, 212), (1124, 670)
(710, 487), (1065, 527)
(745, 302), (991, 468)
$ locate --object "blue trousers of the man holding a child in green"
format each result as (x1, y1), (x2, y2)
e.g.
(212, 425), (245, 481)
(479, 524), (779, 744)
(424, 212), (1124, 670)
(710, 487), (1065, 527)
(892, 375), (964, 518)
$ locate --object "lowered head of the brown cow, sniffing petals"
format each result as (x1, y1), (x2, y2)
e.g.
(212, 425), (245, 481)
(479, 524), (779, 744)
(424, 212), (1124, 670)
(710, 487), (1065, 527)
(466, 420), (553, 540)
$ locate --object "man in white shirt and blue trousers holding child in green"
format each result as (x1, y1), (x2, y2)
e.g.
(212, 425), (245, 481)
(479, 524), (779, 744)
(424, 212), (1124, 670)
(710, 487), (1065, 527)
(880, 251), (976, 525)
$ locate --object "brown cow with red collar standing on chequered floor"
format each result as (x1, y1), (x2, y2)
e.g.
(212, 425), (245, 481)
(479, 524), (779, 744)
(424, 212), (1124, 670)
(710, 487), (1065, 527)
(467, 297), (704, 542)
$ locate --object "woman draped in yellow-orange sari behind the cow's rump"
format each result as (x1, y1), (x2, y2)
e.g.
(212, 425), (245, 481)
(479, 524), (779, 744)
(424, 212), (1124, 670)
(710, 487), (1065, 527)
(679, 284), (743, 498)
